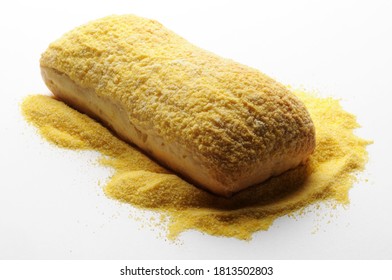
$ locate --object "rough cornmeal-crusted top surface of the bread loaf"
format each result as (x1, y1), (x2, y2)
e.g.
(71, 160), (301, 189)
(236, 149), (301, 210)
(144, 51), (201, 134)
(41, 15), (314, 175)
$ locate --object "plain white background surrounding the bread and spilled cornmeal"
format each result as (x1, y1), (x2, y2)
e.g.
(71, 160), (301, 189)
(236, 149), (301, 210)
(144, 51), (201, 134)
(0, 0), (392, 259)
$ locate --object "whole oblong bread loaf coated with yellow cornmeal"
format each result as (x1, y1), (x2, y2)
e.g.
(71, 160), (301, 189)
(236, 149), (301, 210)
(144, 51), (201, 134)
(40, 15), (315, 196)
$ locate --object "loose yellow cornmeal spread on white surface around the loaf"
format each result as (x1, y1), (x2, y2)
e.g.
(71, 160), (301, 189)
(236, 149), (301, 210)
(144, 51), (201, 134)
(22, 91), (370, 239)
